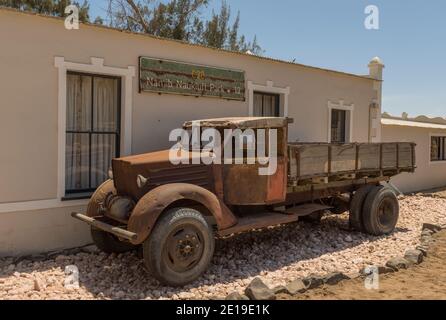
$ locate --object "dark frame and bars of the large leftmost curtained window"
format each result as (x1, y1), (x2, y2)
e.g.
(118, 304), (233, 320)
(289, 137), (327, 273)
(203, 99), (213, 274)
(62, 70), (122, 196)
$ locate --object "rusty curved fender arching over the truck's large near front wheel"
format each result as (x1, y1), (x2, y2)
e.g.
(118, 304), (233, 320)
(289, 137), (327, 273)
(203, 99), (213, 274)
(127, 183), (237, 245)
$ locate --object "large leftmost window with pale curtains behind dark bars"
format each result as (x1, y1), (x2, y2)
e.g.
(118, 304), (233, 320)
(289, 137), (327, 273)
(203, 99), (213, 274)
(65, 73), (121, 196)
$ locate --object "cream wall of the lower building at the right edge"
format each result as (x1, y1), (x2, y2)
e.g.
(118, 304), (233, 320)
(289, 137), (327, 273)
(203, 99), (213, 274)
(382, 125), (446, 193)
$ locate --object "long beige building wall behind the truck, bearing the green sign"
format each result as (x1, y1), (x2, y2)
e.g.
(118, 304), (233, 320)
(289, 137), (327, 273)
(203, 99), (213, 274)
(0, 10), (380, 255)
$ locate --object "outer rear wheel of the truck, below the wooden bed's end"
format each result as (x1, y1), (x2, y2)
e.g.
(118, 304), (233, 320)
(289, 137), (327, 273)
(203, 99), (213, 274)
(362, 186), (399, 236)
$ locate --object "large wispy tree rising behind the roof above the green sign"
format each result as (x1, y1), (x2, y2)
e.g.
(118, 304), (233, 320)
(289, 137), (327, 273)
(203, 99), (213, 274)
(108, 0), (262, 54)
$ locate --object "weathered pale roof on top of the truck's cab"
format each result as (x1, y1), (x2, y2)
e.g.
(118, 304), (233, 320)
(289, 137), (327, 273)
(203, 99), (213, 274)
(183, 117), (293, 129)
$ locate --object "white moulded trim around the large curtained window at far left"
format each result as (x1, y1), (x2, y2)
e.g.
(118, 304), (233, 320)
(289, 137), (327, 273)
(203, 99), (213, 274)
(54, 57), (136, 199)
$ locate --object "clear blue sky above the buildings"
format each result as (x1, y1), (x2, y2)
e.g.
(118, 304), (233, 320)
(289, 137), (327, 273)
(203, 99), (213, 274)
(90, 0), (446, 117)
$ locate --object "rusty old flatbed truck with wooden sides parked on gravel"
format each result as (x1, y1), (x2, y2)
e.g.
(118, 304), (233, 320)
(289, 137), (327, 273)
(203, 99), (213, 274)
(72, 118), (415, 286)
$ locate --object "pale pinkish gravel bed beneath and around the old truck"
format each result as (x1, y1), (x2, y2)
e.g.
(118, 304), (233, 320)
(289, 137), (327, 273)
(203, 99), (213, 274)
(0, 195), (446, 299)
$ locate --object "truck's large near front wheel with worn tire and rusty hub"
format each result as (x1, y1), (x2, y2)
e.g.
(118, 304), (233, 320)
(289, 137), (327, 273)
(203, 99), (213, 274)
(143, 208), (215, 287)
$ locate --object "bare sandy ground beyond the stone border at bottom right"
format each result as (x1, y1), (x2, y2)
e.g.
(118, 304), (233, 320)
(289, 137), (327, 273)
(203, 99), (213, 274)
(280, 230), (446, 300)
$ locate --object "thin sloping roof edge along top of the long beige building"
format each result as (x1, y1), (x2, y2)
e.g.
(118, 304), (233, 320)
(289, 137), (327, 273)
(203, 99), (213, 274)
(0, 6), (381, 81)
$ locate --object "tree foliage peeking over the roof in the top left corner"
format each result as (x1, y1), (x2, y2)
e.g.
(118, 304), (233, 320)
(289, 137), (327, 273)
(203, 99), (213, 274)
(0, 0), (90, 22)
